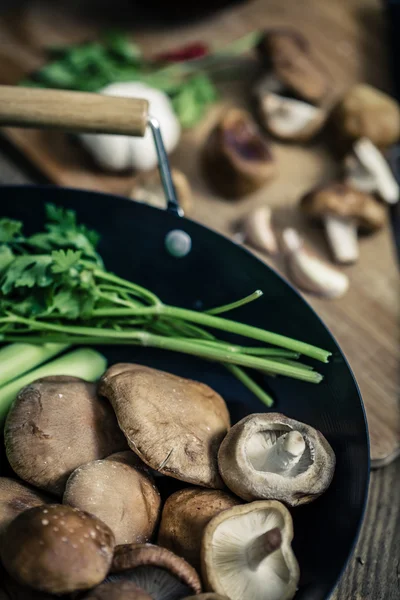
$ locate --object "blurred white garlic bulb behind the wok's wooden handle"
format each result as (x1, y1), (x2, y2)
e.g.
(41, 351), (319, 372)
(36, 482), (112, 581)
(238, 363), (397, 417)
(79, 82), (181, 171)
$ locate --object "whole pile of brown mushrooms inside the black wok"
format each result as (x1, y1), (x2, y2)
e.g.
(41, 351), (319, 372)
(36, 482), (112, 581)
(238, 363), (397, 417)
(0, 363), (335, 600)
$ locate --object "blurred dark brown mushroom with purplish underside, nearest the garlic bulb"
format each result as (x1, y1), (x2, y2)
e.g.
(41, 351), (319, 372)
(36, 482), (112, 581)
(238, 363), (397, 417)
(203, 108), (276, 198)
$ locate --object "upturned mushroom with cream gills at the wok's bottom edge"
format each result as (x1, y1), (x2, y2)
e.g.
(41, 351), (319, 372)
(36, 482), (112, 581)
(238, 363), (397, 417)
(202, 501), (299, 600)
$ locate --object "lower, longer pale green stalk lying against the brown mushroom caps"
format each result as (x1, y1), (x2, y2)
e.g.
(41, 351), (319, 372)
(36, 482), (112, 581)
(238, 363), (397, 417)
(0, 348), (107, 425)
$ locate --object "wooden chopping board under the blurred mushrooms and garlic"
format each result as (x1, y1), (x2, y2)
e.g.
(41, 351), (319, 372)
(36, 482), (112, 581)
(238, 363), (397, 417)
(0, 0), (400, 467)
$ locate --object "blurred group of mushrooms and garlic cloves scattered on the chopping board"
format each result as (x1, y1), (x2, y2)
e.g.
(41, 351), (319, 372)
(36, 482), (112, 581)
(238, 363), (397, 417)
(203, 28), (400, 299)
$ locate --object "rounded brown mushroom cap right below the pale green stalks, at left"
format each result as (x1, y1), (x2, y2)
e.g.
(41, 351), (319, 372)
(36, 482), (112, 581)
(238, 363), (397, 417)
(4, 375), (126, 495)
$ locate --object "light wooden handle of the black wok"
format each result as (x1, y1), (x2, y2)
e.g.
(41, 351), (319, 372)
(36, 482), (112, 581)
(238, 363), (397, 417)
(0, 86), (149, 136)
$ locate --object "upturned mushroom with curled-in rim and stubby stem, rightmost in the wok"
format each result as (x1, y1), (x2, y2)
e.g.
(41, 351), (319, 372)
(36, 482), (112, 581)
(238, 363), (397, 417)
(218, 413), (335, 506)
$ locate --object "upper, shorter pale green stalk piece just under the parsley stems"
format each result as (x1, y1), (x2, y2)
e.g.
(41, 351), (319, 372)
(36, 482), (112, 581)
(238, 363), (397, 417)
(0, 344), (68, 386)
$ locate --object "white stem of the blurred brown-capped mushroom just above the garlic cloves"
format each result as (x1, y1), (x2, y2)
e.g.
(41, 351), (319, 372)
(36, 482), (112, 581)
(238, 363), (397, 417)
(324, 215), (359, 264)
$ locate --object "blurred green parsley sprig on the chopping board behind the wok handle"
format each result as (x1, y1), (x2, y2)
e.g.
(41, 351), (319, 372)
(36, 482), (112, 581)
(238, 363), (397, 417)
(21, 31), (260, 128)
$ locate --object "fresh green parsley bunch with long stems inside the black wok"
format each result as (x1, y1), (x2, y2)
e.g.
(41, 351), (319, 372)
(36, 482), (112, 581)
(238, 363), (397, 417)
(0, 204), (329, 406)
